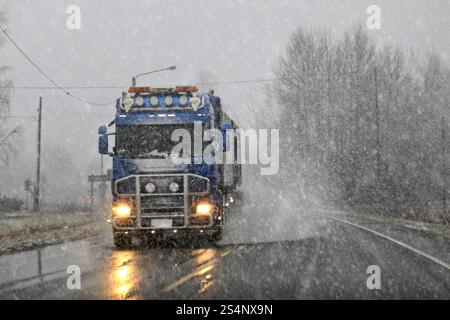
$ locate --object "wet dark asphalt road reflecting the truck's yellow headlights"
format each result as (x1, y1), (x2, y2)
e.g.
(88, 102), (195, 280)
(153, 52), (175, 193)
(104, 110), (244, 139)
(0, 209), (450, 299)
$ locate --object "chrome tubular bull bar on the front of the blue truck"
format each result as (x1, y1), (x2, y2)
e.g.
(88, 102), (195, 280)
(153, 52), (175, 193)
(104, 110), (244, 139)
(113, 173), (213, 230)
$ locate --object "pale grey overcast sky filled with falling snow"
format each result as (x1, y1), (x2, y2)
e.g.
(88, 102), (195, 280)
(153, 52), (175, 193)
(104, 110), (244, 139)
(0, 0), (450, 201)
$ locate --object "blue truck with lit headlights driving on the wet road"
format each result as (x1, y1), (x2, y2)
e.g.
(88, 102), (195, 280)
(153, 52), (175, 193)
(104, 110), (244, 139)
(98, 86), (242, 247)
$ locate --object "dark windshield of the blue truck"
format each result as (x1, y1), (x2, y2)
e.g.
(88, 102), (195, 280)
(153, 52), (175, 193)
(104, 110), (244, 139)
(116, 123), (208, 159)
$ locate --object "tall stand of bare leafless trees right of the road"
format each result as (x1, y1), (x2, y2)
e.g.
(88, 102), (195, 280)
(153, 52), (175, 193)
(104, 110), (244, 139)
(274, 25), (450, 221)
